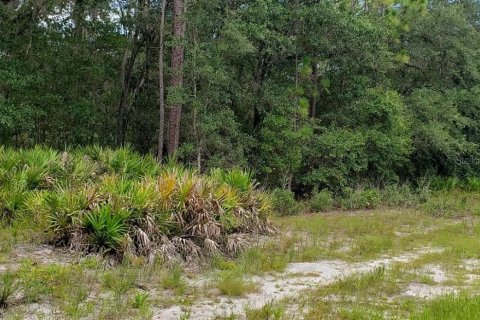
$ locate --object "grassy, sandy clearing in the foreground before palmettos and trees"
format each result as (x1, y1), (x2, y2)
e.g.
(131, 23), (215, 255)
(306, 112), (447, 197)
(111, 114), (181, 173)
(0, 209), (480, 320)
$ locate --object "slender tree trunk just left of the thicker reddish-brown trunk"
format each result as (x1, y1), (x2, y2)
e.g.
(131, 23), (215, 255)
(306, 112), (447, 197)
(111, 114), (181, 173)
(157, 0), (167, 161)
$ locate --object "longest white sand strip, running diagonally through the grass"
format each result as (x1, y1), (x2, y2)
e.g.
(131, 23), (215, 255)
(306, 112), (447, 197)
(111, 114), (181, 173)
(153, 248), (441, 320)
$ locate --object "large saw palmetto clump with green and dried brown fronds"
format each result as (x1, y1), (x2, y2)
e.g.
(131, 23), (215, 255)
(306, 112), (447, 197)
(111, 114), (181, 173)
(0, 146), (272, 259)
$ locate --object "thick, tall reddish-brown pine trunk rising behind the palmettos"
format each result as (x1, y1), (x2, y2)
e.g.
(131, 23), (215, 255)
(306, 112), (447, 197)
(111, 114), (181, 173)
(167, 0), (185, 156)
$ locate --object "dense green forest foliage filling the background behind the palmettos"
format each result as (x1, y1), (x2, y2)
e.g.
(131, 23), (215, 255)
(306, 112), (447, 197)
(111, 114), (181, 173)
(0, 0), (480, 192)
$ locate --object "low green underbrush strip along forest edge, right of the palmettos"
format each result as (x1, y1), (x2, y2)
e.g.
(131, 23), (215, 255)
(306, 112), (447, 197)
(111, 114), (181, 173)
(272, 177), (480, 218)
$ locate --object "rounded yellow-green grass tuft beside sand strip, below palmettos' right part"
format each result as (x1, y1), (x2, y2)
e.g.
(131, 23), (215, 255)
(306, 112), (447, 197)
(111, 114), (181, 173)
(216, 269), (257, 297)
